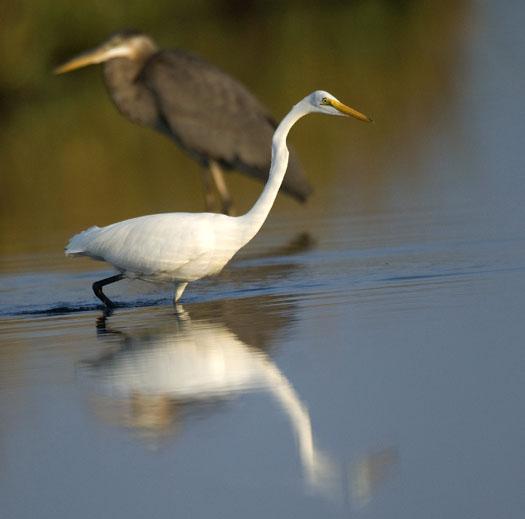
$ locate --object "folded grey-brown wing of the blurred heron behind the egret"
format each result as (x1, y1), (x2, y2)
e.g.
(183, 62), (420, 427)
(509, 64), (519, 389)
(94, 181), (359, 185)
(139, 50), (311, 201)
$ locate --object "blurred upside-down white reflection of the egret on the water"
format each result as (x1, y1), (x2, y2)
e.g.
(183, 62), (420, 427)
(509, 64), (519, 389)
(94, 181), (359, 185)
(82, 298), (336, 493)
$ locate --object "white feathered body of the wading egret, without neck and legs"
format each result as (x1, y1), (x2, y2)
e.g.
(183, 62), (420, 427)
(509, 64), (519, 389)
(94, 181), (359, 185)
(66, 213), (239, 282)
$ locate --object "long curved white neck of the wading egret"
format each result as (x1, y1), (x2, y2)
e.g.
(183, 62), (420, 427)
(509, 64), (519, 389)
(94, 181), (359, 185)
(238, 101), (308, 245)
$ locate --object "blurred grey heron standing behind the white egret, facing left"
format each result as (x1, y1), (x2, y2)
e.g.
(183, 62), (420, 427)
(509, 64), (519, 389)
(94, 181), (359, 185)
(55, 31), (312, 214)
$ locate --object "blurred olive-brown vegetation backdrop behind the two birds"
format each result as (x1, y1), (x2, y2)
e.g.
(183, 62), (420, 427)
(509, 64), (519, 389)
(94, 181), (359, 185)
(0, 0), (468, 254)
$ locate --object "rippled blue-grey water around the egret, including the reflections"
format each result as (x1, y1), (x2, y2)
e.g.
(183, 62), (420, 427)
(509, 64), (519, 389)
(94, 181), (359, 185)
(0, 3), (525, 519)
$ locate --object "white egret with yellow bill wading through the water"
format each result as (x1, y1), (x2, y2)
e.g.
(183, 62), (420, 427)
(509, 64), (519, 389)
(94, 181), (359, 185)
(65, 90), (371, 307)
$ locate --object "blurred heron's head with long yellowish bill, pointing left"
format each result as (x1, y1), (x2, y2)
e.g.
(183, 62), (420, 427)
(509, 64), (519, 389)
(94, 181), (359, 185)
(54, 30), (157, 74)
